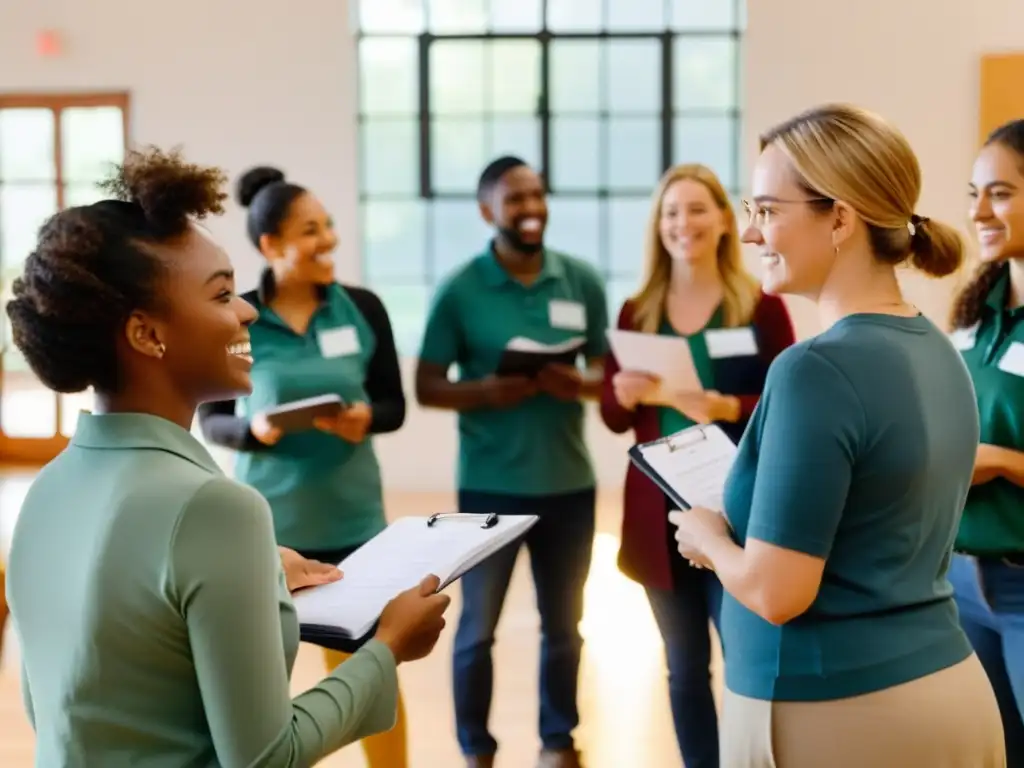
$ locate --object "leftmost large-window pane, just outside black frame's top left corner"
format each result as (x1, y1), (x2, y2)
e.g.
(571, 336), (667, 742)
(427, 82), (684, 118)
(359, 38), (420, 116)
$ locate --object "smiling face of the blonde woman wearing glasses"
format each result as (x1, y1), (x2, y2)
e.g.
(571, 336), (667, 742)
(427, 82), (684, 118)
(741, 144), (836, 299)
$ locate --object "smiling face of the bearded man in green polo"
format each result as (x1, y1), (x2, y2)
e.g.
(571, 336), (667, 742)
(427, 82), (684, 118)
(480, 166), (548, 254)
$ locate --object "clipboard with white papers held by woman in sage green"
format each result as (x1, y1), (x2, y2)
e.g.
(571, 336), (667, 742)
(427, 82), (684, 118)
(294, 512), (538, 650)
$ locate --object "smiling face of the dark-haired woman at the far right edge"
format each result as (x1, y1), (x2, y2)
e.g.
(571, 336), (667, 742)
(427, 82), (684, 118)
(970, 143), (1024, 262)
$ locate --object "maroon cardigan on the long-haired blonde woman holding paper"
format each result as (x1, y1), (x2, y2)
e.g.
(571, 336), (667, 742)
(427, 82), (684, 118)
(601, 294), (795, 590)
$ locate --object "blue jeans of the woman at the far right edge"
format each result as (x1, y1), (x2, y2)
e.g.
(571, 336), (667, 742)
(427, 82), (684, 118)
(949, 555), (1024, 768)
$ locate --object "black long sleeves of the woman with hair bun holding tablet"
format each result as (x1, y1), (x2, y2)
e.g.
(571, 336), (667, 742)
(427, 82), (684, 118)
(199, 276), (406, 451)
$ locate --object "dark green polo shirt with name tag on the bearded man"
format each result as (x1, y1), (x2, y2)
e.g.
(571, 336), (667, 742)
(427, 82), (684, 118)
(420, 249), (608, 496)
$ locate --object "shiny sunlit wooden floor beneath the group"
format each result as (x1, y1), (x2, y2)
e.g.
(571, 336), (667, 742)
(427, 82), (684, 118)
(0, 475), (721, 768)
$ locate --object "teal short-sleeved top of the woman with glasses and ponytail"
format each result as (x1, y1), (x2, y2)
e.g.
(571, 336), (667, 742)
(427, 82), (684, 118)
(722, 314), (978, 700)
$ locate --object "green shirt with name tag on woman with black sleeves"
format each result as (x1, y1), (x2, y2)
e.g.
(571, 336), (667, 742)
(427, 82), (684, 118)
(236, 284), (386, 550)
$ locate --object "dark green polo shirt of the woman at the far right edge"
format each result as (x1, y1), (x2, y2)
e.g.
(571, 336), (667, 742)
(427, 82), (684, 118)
(951, 270), (1024, 555)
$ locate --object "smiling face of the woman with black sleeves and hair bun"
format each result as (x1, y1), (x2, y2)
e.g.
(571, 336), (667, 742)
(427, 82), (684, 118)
(260, 193), (338, 286)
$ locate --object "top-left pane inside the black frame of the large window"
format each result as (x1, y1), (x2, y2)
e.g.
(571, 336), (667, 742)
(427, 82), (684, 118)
(430, 40), (486, 115)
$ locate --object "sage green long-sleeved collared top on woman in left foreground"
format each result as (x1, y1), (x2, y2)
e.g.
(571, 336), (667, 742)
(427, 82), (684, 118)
(7, 414), (397, 768)
